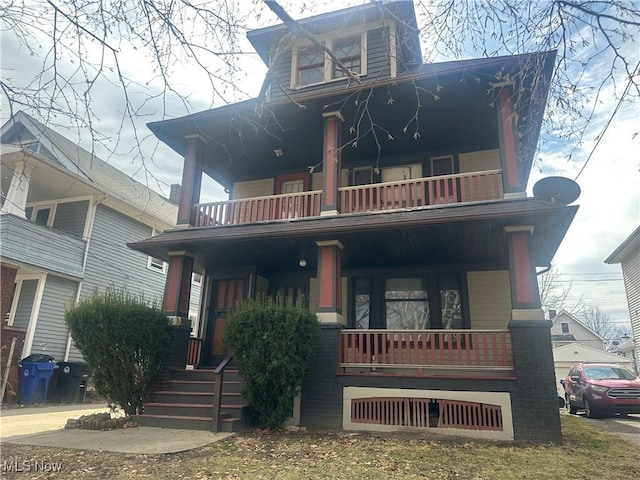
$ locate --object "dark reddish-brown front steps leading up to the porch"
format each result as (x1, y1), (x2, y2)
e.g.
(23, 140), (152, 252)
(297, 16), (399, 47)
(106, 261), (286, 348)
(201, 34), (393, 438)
(136, 369), (246, 432)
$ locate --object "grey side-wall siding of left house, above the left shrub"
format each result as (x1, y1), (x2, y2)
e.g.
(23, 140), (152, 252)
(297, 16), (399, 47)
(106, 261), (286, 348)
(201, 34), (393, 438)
(81, 205), (166, 303)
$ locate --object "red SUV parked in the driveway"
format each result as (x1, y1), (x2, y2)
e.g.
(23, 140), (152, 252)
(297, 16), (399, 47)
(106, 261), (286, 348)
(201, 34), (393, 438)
(564, 363), (640, 418)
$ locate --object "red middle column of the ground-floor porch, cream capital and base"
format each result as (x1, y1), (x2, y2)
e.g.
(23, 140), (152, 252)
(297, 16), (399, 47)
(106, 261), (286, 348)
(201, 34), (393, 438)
(316, 240), (346, 325)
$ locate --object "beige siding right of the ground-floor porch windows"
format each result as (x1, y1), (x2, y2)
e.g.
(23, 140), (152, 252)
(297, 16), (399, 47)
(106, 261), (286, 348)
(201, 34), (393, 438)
(467, 270), (511, 329)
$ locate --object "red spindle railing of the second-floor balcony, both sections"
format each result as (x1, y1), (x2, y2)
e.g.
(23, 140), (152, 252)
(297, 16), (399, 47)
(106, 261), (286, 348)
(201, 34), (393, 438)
(195, 170), (504, 227)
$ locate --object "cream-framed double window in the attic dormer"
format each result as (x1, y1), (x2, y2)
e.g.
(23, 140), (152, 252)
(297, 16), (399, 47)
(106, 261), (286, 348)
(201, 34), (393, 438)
(291, 32), (367, 87)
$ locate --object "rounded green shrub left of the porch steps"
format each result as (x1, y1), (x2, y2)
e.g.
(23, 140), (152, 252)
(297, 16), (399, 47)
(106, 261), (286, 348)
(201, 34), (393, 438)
(65, 289), (171, 415)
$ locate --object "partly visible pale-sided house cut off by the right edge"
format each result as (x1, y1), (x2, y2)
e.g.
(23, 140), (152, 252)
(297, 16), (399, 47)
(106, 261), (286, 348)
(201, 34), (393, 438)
(605, 227), (640, 372)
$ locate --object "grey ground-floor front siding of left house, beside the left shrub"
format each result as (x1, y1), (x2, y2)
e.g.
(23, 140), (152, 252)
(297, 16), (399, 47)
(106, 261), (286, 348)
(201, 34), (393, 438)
(31, 275), (78, 361)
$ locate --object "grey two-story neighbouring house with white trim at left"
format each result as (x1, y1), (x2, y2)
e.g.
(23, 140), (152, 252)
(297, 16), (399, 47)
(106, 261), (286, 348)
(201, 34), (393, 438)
(0, 112), (198, 402)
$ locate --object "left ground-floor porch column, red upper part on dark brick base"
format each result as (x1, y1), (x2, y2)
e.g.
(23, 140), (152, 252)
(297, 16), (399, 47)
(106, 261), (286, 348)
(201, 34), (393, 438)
(162, 251), (194, 368)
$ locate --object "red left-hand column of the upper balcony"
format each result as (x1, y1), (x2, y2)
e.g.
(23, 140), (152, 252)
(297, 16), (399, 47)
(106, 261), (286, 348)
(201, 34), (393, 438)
(177, 135), (205, 227)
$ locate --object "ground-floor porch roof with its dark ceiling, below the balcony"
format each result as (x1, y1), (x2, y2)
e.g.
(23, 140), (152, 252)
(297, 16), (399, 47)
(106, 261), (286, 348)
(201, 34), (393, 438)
(130, 199), (577, 272)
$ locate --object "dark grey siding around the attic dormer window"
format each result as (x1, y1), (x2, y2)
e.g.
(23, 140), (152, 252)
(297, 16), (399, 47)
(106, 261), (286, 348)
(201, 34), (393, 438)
(270, 27), (391, 101)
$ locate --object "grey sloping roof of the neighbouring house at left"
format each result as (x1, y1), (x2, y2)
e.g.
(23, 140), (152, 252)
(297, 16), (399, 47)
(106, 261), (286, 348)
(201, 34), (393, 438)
(2, 111), (177, 225)
